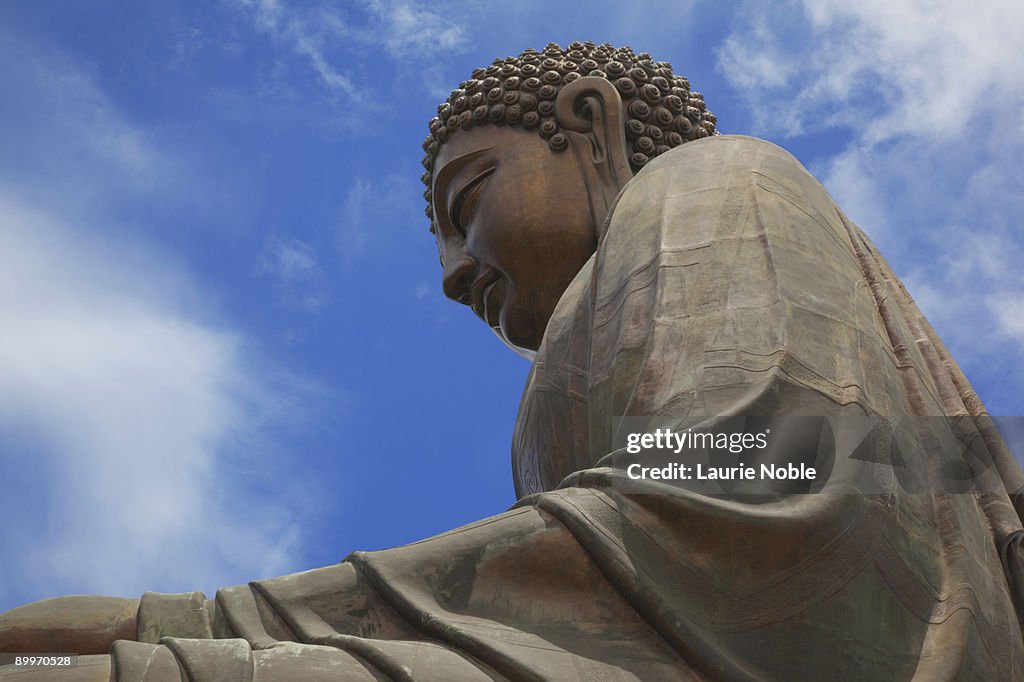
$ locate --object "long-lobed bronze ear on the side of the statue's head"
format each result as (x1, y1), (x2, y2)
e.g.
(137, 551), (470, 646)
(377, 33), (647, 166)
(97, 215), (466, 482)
(555, 76), (633, 194)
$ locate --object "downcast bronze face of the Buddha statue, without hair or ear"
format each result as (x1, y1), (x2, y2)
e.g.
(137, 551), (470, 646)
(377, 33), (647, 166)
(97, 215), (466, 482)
(433, 126), (604, 350)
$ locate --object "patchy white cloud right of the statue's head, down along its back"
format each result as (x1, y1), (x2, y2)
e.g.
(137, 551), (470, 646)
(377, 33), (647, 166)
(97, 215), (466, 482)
(718, 0), (1024, 411)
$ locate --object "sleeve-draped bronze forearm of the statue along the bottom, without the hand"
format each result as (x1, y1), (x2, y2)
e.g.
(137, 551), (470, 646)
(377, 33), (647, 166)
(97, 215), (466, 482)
(72, 501), (687, 682)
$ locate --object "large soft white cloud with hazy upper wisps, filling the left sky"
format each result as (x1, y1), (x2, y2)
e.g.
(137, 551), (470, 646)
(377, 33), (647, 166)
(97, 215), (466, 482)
(0, 30), (321, 609)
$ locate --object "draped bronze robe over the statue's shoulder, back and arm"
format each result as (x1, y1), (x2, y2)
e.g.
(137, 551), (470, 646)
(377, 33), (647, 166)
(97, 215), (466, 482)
(111, 136), (1024, 682)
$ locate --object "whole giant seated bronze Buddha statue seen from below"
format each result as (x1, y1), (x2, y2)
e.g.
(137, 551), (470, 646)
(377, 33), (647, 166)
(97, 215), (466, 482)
(6, 43), (1024, 682)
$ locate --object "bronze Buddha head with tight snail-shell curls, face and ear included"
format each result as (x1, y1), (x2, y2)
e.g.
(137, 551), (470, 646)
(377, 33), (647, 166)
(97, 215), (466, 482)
(423, 43), (716, 352)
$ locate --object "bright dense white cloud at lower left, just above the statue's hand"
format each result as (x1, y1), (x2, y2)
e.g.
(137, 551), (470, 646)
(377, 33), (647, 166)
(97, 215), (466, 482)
(0, 192), (317, 595)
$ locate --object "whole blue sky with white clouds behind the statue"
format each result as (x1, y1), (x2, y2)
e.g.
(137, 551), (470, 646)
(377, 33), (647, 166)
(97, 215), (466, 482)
(0, 0), (1024, 609)
